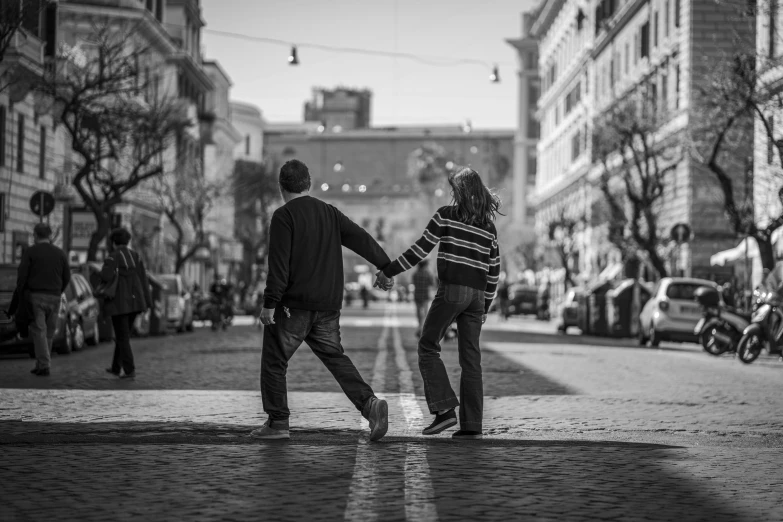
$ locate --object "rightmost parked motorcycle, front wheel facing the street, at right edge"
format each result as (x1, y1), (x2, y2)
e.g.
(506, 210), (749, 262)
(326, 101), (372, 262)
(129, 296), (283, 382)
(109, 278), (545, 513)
(737, 289), (783, 364)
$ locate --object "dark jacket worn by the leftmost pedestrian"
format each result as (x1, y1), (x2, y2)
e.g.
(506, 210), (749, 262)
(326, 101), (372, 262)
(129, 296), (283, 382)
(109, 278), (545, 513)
(16, 243), (71, 296)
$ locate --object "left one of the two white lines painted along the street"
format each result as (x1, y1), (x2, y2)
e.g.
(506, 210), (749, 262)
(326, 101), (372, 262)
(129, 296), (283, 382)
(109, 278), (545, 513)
(344, 308), (391, 522)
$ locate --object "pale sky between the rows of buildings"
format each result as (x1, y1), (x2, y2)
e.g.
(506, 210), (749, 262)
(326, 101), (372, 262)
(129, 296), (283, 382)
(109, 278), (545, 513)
(202, 0), (533, 128)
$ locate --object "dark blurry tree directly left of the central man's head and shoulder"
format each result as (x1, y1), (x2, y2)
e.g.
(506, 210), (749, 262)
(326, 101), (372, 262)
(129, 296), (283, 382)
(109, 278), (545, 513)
(234, 160), (282, 283)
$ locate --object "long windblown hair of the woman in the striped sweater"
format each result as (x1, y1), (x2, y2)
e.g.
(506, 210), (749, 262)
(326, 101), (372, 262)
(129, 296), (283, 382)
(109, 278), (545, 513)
(449, 167), (503, 228)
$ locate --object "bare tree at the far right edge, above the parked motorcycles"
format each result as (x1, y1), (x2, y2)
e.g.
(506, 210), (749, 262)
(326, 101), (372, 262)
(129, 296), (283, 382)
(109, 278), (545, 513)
(691, 3), (783, 269)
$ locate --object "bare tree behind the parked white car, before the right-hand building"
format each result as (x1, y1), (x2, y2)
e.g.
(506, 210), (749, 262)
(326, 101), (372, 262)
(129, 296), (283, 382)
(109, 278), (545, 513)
(593, 87), (682, 277)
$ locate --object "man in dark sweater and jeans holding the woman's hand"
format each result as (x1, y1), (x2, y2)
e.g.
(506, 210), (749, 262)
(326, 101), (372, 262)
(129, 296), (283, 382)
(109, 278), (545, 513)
(251, 160), (391, 440)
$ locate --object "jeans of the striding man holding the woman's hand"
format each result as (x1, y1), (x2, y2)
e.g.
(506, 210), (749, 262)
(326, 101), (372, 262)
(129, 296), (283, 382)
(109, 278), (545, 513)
(261, 306), (375, 429)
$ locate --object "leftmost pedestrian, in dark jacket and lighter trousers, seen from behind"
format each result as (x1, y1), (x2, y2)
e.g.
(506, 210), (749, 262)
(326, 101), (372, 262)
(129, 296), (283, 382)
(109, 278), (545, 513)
(9, 223), (71, 377)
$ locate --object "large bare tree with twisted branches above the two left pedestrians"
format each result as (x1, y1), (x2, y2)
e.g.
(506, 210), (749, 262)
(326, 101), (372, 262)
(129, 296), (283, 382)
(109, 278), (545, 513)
(40, 22), (191, 260)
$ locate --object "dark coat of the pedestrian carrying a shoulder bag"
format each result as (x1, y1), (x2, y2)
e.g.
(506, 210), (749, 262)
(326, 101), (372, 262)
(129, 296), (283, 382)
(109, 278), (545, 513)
(101, 247), (152, 316)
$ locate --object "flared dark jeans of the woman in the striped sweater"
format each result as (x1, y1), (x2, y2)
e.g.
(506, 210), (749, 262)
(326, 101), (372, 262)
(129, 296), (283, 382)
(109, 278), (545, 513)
(419, 283), (484, 431)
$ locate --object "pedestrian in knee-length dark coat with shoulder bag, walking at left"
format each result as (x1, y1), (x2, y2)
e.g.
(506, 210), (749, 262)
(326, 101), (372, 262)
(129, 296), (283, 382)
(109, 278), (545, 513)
(101, 228), (152, 379)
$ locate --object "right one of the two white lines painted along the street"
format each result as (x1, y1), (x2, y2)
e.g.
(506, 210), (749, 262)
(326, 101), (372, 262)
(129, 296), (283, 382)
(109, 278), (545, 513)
(392, 305), (438, 522)
